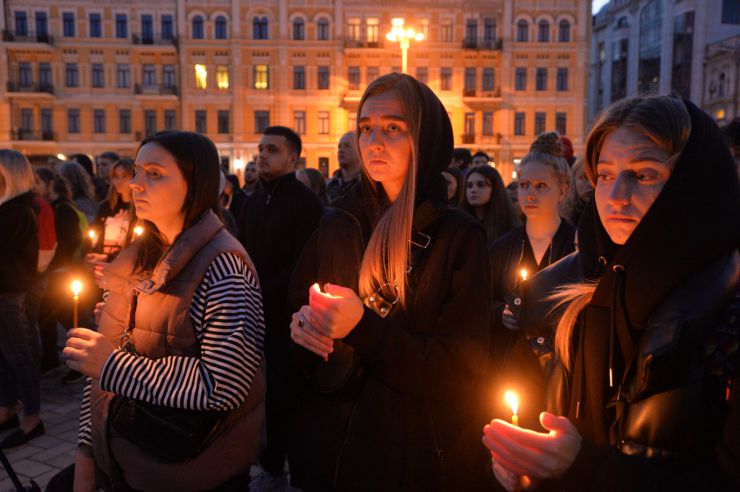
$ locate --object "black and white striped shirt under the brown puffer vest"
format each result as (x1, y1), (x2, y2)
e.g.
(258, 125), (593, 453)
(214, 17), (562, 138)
(78, 253), (265, 445)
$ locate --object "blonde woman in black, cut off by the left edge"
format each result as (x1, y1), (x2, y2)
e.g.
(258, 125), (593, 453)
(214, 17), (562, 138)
(0, 149), (44, 449)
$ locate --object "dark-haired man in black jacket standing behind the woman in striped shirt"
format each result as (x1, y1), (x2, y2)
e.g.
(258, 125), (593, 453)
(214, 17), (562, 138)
(239, 126), (323, 488)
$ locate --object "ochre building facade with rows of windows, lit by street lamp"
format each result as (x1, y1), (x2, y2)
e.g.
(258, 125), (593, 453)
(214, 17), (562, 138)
(0, 0), (591, 181)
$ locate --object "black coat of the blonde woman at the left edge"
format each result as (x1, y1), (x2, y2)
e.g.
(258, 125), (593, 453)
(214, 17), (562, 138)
(0, 191), (39, 294)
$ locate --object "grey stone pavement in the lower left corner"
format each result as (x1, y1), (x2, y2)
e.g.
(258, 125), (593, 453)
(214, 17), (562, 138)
(0, 366), (83, 492)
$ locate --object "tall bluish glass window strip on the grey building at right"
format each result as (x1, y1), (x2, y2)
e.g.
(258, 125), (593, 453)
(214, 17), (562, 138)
(637, 0), (663, 94)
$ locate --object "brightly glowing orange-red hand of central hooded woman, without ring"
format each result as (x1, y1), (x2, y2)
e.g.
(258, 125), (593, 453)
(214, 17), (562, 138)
(309, 284), (364, 339)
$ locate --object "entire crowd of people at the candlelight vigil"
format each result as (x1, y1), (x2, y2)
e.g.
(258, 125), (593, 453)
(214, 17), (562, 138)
(0, 73), (740, 492)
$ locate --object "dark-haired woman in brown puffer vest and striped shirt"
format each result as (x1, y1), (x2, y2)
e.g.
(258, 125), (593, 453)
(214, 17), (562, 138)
(64, 131), (265, 490)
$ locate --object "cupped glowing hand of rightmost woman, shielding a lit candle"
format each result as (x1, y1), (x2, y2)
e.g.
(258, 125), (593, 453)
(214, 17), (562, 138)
(483, 412), (582, 485)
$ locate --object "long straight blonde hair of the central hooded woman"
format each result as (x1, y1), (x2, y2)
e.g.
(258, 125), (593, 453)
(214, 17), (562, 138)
(355, 74), (421, 306)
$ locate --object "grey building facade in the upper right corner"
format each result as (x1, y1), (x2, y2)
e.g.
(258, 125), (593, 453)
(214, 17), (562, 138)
(588, 0), (740, 124)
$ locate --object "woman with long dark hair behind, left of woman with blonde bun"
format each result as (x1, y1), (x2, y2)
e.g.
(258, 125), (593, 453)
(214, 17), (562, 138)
(463, 166), (519, 243)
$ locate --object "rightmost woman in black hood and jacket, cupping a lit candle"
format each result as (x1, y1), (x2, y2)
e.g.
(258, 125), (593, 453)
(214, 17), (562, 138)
(483, 96), (740, 490)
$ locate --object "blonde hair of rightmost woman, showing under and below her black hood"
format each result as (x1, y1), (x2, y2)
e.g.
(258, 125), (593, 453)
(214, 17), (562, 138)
(549, 96), (691, 369)
